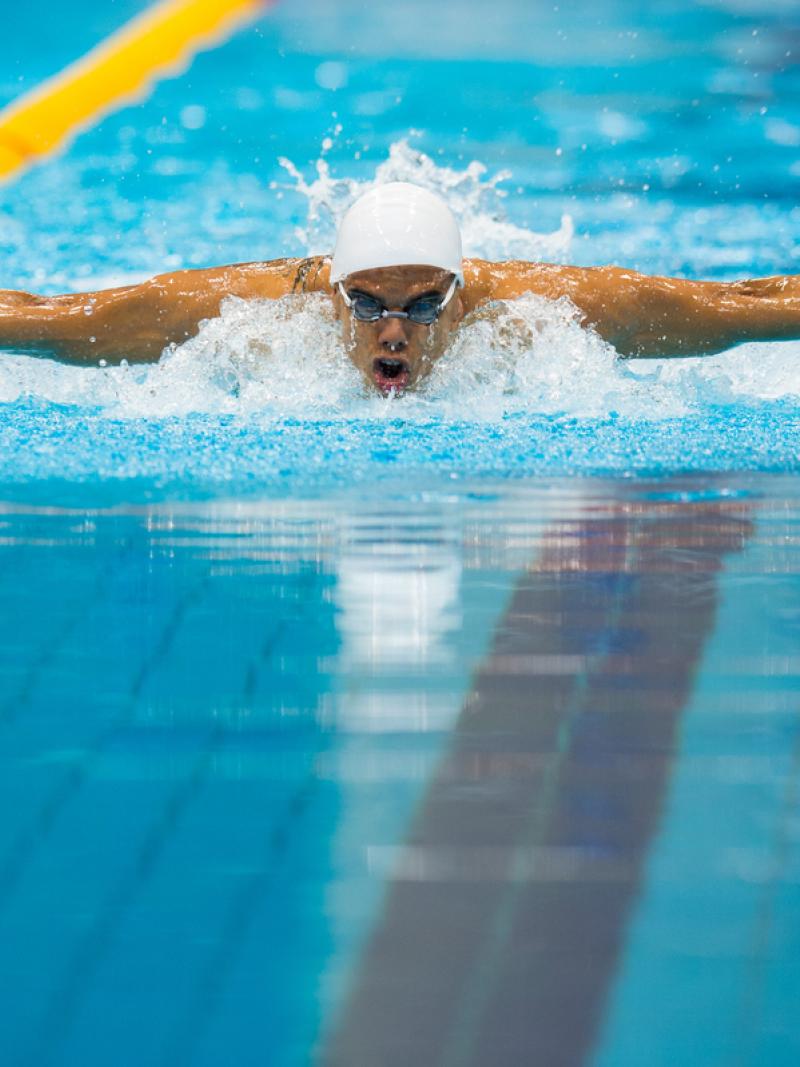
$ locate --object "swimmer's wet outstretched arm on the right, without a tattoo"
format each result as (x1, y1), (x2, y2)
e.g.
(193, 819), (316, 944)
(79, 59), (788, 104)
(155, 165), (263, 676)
(479, 262), (800, 357)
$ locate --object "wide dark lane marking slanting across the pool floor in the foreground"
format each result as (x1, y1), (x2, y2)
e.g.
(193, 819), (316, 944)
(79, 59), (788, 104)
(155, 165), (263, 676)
(322, 504), (750, 1067)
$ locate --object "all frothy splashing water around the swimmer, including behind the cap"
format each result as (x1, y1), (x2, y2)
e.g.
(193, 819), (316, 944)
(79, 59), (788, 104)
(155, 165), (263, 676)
(0, 141), (800, 484)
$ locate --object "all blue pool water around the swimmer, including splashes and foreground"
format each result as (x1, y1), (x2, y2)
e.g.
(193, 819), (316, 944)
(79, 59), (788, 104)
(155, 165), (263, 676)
(0, 0), (800, 1067)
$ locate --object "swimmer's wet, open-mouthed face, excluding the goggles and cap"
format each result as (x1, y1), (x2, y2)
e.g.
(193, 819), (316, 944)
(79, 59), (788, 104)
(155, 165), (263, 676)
(334, 267), (464, 393)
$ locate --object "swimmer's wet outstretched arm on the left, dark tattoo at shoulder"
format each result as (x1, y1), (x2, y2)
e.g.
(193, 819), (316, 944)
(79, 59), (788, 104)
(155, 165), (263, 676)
(0, 258), (324, 365)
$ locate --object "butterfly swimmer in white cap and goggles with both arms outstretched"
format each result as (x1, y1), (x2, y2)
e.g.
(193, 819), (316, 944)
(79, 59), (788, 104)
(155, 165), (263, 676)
(0, 181), (800, 393)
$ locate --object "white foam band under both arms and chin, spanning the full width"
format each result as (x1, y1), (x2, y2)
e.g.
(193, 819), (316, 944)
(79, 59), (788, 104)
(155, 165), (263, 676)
(0, 293), (800, 423)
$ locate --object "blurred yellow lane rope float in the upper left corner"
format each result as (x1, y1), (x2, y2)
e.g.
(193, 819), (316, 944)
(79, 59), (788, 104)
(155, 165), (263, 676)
(0, 0), (274, 180)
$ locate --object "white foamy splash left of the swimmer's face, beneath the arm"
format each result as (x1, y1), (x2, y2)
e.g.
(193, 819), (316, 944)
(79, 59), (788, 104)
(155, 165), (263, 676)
(0, 294), (363, 418)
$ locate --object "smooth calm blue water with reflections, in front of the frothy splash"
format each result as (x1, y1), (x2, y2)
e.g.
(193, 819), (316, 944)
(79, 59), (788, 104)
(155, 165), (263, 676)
(0, 476), (800, 1067)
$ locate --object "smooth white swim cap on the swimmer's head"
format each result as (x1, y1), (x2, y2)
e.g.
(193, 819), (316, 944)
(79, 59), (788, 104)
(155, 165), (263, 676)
(331, 181), (464, 285)
